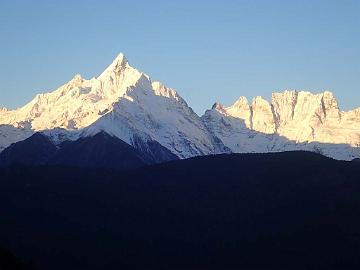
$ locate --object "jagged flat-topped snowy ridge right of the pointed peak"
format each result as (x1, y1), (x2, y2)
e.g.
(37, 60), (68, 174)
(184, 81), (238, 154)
(202, 91), (360, 160)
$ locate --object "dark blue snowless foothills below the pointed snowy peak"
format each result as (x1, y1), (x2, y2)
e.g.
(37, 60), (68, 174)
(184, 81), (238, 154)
(0, 132), (177, 169)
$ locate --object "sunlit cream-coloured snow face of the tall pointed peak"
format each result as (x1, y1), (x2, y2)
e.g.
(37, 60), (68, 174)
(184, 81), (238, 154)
(0, 53), (160, 131)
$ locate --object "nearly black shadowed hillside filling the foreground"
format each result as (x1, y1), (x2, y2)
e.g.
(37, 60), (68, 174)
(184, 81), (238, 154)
(0, 152), (360, 270)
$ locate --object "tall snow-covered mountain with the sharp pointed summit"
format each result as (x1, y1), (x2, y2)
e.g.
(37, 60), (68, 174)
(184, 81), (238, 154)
(0, 54), (226, 158)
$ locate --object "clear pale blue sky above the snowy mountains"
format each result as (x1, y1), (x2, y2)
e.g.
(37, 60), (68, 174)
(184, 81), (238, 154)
(0, 0), (360, 114)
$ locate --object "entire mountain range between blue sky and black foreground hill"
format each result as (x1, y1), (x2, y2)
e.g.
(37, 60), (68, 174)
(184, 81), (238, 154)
(0, 54), (360, 168)
